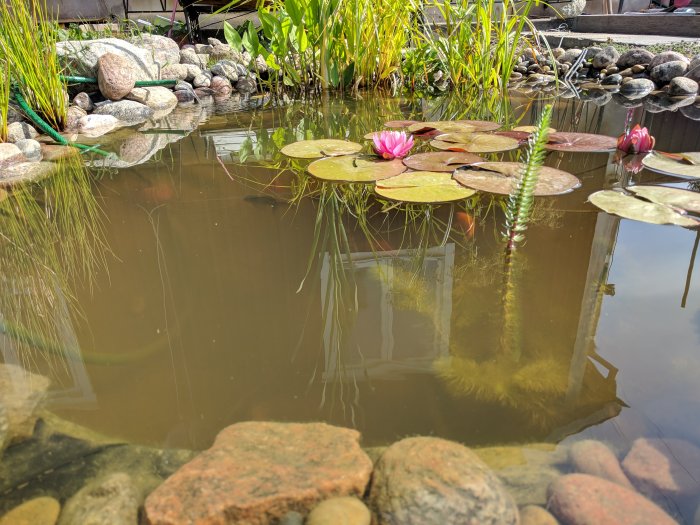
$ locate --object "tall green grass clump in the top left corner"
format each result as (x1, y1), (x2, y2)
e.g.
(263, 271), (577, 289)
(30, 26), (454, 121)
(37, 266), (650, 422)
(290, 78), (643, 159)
(0, 0), (66, 130)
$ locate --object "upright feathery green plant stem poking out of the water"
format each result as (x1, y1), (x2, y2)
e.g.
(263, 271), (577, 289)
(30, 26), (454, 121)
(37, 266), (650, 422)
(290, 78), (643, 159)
(504, 105), (552, 250)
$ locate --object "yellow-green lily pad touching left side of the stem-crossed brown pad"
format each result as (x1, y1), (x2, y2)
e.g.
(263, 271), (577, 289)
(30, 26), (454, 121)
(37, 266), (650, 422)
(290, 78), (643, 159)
(375, 171), (476, 203)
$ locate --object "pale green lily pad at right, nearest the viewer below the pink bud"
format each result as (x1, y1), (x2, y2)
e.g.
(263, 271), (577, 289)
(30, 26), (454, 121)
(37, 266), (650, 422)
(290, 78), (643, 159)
(588, 190), (700, 228)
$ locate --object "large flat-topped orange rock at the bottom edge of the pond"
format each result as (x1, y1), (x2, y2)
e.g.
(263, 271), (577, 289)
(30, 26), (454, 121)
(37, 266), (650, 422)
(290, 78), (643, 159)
(145, 422), (372, 525)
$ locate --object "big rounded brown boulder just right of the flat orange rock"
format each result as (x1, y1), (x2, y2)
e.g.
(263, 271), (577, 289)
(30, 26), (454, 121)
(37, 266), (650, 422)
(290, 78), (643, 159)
(369, 437), (518, 525)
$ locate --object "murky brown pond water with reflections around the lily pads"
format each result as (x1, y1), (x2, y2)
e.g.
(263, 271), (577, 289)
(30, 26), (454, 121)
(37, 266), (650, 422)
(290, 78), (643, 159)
(0, 93), (700, 520)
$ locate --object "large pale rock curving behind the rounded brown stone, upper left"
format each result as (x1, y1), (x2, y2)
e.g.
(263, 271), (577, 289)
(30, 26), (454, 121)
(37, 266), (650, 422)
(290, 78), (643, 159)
(56, 38), (158, 80)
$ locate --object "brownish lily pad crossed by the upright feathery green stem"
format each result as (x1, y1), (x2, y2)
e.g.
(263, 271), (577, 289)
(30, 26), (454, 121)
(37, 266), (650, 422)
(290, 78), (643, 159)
(453, 162), (581, 196)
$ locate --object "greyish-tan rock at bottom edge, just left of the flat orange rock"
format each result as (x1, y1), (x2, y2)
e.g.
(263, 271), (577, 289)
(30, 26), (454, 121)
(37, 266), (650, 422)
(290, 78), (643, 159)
(58, 472), (142, 525)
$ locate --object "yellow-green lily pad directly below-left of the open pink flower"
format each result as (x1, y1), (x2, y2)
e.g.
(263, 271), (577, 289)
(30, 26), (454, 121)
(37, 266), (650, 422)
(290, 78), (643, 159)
(307, 155), (406, 182)
